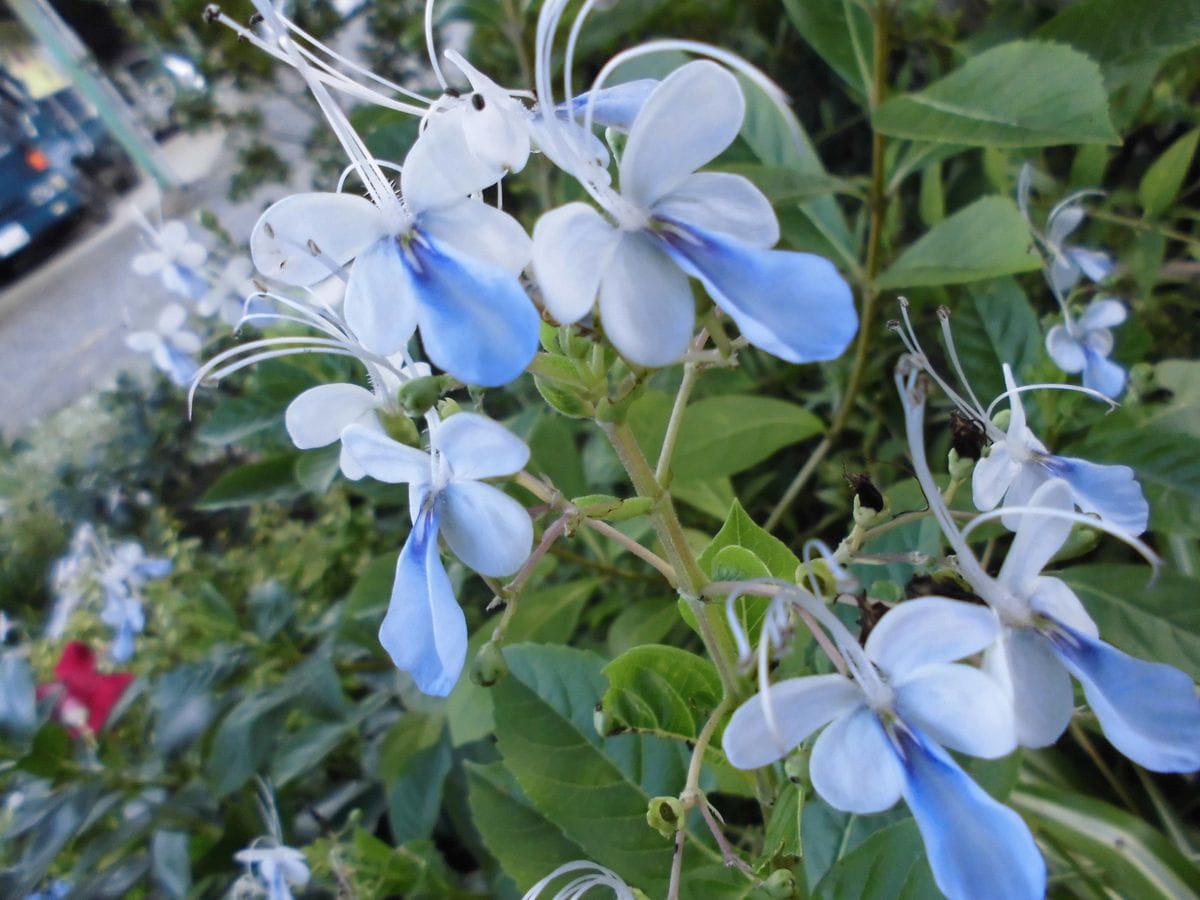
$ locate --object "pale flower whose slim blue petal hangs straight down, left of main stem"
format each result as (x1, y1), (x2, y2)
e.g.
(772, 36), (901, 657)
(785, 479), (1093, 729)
(342, 413), (533, 697)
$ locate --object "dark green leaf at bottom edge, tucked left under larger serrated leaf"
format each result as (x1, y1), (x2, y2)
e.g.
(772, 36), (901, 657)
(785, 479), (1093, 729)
(466, 762), (587, 890)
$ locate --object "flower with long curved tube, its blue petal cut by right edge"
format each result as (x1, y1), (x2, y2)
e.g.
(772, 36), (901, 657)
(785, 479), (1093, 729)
(898, 361), (1200, 772)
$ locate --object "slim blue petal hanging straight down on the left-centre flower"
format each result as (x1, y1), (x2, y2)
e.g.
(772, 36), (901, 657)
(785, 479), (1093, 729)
(379, 510), (467, 697)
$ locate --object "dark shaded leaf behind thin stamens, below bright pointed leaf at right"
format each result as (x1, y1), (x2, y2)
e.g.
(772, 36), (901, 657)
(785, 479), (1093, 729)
(945, 278), (1042, 400)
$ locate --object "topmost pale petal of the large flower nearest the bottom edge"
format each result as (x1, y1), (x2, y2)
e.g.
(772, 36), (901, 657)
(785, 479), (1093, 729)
(866, 596), (1000, 682)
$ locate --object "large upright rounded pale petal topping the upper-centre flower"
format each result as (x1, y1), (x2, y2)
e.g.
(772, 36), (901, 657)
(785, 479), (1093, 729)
(620, 60), (745, 208)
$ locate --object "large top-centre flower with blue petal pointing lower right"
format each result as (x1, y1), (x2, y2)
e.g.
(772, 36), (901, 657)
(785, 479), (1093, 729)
(533, 60), (858, 366)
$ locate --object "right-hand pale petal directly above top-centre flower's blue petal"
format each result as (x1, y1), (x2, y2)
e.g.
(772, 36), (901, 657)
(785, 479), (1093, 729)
(653, 172), (779, 248)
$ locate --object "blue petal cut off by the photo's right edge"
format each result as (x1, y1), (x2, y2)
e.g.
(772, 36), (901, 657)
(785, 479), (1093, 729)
(1045, 622), (1200, 772)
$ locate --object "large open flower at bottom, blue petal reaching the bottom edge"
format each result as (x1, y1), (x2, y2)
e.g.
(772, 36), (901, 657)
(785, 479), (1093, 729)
(724, 598), (1045, 900)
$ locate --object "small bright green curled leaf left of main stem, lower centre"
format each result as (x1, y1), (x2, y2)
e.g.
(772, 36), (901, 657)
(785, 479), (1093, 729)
(601, 644), (721, 740)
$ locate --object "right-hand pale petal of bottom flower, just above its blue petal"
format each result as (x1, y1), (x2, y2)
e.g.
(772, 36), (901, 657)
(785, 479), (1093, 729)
(896, 664), (1016, 760)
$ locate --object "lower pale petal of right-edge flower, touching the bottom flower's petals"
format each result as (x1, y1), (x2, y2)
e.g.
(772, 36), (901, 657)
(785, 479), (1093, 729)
(984, 628), (1075, 748)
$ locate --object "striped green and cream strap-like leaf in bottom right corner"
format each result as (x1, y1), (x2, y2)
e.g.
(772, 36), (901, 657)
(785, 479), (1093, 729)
(1009, 787), (1200, 900)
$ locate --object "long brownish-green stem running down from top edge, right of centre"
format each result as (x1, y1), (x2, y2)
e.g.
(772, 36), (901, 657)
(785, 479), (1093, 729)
(764, 0), (888, 532)
